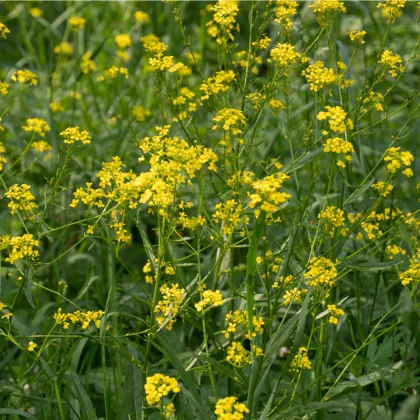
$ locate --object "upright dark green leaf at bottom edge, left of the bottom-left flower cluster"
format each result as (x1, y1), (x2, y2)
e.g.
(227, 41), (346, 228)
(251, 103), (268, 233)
(121, 363), (143, 420)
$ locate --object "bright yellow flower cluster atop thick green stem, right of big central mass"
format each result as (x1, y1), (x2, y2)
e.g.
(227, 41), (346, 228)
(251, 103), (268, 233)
(248, 172), (292, 216)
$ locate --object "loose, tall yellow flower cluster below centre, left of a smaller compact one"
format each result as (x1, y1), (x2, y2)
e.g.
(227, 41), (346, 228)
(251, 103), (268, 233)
(154, 284), (185, 330)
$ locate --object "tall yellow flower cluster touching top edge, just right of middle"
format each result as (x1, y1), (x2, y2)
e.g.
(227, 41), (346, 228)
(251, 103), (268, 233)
(207, 0), (239, 44)
